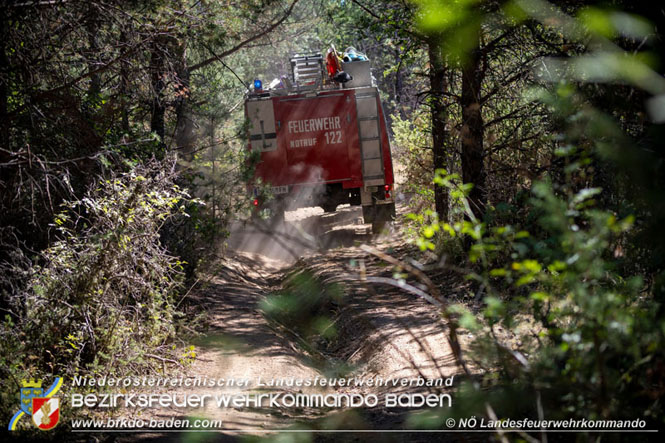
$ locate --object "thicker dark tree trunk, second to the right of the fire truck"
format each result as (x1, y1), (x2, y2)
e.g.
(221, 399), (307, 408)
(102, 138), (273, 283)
(461, 27), (486, 218)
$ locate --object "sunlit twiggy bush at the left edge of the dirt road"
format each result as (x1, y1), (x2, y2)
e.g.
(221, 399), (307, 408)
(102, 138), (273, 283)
(0, 161), (189, 424)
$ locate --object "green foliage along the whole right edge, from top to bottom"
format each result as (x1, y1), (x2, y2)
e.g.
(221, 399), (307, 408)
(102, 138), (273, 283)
(400, 1), (665, 427)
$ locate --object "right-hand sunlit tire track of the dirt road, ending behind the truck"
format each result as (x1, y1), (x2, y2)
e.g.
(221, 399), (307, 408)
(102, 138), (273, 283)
(220, 207), (468, 440)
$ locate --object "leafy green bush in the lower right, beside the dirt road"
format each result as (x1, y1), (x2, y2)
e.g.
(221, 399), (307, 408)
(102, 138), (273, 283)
(412, 166), (665, 426)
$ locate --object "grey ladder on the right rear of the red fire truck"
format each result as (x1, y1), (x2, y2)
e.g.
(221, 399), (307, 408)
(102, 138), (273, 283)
(356, 89), (385, 187)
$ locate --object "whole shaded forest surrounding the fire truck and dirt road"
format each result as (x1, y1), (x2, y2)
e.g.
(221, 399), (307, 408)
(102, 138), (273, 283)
(0, 0), (665, 438)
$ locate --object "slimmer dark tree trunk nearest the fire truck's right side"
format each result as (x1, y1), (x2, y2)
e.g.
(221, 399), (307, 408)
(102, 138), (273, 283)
(427, 36), (450, 221)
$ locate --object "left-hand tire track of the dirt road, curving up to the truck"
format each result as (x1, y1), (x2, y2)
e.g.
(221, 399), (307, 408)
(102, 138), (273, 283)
(117, 207), (378, 441)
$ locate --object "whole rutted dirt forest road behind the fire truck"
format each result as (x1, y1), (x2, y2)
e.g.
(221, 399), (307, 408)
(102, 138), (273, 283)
(120, 206), (472, 441)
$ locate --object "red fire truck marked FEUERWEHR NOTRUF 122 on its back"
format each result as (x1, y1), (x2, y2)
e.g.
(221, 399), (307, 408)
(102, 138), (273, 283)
(245, 54), (395, 231)
